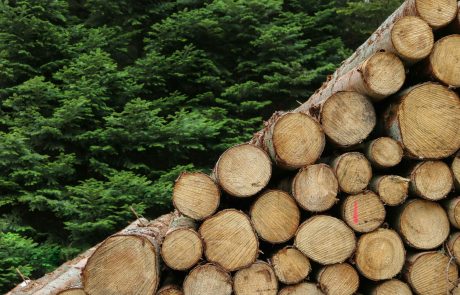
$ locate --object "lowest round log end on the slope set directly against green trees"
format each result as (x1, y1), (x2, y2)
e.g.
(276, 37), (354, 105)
(172, 172), (220, 220)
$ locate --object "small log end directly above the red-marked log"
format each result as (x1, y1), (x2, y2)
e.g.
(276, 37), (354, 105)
(332, 152), (372, 194)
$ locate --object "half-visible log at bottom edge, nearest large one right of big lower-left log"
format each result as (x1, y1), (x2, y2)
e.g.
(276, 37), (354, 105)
(184, 263), (232, 295)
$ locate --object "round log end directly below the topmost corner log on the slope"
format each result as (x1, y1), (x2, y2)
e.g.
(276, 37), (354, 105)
(391, 16), (434, 63)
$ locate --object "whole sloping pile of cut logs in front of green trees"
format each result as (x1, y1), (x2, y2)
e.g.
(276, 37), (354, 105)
(6, 0), (460, 295)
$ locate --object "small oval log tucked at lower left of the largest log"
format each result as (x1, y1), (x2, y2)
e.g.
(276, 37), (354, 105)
(365, 137), (403, 168)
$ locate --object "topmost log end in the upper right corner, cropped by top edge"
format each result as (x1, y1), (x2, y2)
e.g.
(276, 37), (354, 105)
(415, 0), (457, 29)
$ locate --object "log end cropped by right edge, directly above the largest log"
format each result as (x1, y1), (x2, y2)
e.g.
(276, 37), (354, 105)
(429, 35), (460, 87)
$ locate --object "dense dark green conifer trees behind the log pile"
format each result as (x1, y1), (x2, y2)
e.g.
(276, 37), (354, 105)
(0, 0), (401, 292)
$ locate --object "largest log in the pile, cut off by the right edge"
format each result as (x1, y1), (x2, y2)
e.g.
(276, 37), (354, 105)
(385, 82), (460, 159)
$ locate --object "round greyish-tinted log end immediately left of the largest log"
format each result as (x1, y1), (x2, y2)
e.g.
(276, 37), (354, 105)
(321, 91), (376, 147)
